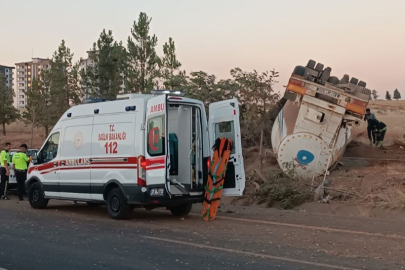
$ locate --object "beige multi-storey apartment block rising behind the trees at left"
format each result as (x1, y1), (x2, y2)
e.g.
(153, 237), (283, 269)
(15, 58), (50, 109)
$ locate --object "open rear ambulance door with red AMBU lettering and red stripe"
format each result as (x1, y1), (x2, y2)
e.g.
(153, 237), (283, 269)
(145, 95), (170, 192)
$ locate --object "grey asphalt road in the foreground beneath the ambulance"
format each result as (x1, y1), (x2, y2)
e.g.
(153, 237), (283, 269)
(0, 197), (405, 270)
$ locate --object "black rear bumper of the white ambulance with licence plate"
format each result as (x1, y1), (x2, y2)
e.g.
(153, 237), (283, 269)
(126, 185), (204, 207)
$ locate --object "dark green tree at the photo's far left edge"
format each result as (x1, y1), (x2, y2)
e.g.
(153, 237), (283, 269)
(0, 73), (19, 136)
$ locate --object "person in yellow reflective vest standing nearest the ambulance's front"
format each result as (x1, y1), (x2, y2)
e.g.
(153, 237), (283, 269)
(12, 144), (32, 201)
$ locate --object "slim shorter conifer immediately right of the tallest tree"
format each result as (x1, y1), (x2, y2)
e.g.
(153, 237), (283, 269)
(159, 38), (187, 90)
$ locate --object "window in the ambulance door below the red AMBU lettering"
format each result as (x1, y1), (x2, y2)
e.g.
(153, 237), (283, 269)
(147, 115), (166, 156)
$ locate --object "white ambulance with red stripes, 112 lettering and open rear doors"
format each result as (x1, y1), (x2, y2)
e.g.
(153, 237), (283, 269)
(26, 91), (245, 219)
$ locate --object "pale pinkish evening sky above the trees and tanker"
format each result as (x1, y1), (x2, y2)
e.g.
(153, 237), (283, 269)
(0, 0), (405, 98)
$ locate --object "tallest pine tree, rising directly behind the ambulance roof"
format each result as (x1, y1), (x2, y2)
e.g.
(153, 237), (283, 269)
(126, 12), (160, 93)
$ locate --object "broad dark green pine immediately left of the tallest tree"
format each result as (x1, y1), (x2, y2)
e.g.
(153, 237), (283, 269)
(80, 29), (126, 99)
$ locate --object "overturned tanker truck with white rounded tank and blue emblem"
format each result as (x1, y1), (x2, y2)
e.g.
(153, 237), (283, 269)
(271, 60), (371, 179)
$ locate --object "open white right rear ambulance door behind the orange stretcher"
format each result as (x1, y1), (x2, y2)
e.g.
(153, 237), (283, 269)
(208, 99), (245, 196)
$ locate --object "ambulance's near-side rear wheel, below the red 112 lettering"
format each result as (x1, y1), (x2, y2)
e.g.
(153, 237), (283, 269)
(107, 188), (132, 219)
